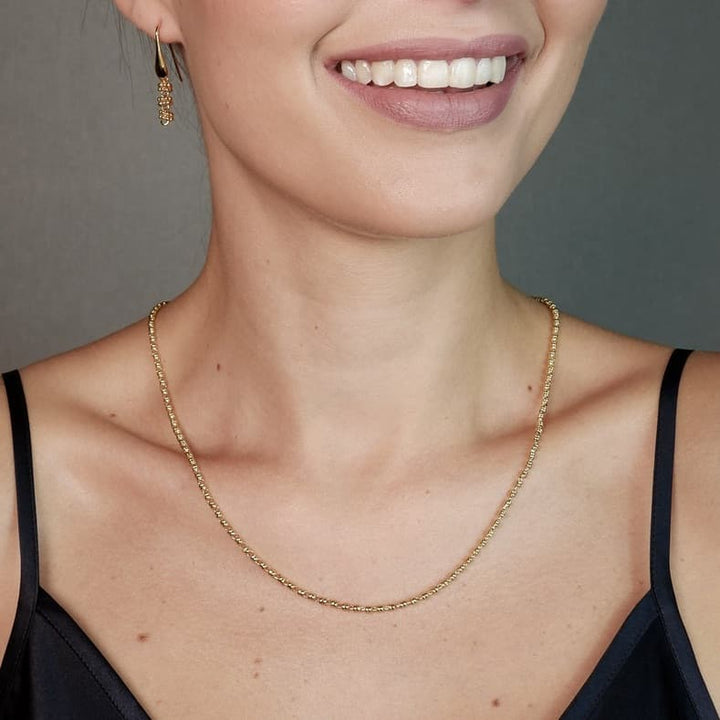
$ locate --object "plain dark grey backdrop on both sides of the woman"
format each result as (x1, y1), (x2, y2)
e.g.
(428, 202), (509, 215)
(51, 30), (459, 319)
(0, 0), (720, 369)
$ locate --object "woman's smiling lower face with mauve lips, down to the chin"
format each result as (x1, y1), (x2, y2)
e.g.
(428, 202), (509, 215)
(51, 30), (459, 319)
(117, 0), (606, 242)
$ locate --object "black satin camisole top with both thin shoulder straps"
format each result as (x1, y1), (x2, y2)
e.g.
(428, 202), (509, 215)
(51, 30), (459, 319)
(0, 349), (720, 720)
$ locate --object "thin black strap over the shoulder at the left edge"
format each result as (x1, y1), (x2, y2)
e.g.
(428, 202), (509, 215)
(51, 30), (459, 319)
(0, 370), (40, 708)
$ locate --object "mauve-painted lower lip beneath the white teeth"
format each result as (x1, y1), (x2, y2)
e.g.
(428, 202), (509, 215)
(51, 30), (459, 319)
(330, 55), (523, 131)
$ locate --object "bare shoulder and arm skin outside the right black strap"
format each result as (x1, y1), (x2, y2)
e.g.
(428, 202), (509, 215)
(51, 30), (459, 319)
(671, 352), (720, 708)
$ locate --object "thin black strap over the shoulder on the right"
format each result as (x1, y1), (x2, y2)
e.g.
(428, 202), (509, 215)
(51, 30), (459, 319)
(650, 348), (692, 605)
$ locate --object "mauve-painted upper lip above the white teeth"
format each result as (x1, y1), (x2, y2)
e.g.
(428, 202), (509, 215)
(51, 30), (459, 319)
(325, 35), (528, 68)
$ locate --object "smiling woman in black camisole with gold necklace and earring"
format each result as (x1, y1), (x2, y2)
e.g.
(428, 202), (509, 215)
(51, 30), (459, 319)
(0, 0), (720, 720)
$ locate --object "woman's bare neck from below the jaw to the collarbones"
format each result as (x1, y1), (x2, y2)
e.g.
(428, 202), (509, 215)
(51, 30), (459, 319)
(158, 155), (550, 478)
